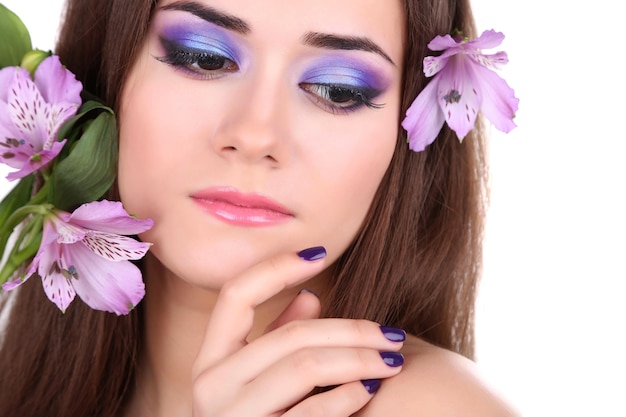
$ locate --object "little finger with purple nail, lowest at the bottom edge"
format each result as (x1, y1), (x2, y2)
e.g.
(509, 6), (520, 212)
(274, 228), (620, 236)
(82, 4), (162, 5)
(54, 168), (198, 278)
(282, 381), (378, 417)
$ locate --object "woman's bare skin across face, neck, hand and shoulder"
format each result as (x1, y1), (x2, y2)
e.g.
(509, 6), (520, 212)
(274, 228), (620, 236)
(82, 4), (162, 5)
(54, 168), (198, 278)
(119, 0), (512, 417)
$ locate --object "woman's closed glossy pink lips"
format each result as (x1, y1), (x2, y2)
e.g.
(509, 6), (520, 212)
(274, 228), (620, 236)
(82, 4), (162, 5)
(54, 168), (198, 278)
(191, 187), (293, 226)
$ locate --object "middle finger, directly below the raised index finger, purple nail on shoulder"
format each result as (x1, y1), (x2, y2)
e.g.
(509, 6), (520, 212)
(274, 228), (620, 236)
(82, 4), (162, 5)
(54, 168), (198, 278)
(211, 319), (405, 386)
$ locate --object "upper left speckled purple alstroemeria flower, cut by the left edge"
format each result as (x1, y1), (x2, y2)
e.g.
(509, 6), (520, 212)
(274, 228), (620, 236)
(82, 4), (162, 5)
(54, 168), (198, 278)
(0, 55), (83, 180)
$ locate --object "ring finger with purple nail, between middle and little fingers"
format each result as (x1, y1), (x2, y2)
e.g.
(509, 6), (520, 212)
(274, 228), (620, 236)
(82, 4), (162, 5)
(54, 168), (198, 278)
(237, 348), (404, 415)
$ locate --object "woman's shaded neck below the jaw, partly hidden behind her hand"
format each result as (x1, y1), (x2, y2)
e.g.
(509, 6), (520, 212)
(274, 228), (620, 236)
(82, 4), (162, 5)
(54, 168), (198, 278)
(128, 252), (332, 417)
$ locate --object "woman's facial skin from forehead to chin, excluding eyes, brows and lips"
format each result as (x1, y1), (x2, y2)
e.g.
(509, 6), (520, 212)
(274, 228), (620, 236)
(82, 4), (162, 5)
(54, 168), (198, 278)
(119, 0), (402, 289)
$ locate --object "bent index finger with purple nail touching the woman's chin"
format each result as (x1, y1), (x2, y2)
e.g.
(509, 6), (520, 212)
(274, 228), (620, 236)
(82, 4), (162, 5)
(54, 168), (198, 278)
(193, 248), (326, 377)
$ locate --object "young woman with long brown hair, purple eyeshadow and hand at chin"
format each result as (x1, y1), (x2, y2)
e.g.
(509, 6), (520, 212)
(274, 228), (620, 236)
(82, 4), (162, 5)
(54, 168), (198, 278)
(0, 0), (515, 417)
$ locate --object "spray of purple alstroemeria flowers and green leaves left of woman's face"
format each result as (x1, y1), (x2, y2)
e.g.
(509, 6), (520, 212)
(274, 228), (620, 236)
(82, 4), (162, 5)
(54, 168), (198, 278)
(0, 4), (153, 315)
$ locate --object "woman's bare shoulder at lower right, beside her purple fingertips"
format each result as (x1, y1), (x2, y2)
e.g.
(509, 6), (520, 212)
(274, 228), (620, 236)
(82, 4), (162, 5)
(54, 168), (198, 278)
(357, 338), (520, 417)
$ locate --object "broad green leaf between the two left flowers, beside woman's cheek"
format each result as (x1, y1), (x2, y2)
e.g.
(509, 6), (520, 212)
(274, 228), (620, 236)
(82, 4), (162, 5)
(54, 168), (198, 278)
(50, 112), (117, 211)
